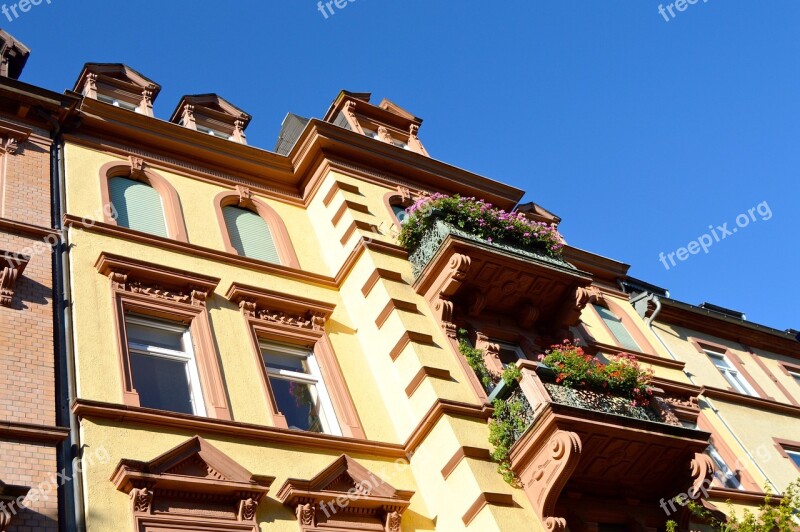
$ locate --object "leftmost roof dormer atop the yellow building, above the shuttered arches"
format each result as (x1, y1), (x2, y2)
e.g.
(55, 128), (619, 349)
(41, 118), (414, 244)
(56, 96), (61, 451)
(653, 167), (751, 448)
(74, 63), (161, 116)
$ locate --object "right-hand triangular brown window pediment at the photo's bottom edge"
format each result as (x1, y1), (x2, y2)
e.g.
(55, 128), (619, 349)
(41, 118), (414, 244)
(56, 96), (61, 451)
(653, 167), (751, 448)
(277, 454), (414, 532)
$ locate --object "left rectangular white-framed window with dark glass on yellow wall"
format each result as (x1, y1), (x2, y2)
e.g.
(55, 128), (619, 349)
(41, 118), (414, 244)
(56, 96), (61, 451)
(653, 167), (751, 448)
(125, 315), (206, 416)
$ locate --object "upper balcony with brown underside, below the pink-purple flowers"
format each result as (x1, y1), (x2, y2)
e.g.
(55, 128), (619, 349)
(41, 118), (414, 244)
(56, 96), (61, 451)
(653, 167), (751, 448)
(409, 220), (591, 336)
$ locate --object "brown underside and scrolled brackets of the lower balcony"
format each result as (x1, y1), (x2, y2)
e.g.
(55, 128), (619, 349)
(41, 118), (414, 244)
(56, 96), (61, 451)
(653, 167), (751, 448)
(511, 403), (712, 530)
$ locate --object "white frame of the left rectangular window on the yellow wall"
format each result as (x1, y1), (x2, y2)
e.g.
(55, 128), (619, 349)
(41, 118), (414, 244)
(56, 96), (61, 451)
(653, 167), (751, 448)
(125, 314), (206, 417)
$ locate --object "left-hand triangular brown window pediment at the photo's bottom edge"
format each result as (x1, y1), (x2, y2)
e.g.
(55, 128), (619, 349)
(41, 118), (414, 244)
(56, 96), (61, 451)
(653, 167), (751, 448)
(111, 436), (275, 531)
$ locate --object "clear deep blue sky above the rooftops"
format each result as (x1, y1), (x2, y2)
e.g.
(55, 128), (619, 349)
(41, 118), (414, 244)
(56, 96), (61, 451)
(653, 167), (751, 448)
(7, 0), (800, 329)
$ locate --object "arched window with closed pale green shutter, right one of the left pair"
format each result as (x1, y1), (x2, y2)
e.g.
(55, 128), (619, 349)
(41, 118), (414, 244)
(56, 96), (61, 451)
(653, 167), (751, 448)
(214, 187), (300, 269)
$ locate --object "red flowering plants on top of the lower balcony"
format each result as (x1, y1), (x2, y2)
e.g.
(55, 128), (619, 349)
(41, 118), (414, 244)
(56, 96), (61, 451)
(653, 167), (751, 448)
(539, 340), (653, 407)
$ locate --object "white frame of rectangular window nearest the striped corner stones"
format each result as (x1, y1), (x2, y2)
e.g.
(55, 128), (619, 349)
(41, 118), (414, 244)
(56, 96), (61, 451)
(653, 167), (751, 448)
(258, 341), (342, 436)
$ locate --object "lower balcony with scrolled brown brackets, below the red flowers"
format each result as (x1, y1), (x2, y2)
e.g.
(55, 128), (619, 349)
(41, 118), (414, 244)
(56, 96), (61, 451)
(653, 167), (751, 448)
(492, 361), (713, 531)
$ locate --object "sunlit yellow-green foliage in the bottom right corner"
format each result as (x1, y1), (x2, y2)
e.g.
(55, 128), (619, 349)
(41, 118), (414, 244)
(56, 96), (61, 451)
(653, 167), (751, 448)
(667, 479), (800, 532)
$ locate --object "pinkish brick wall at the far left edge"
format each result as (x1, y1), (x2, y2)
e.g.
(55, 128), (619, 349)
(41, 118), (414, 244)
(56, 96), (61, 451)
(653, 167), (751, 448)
(0, 127), (58, 532)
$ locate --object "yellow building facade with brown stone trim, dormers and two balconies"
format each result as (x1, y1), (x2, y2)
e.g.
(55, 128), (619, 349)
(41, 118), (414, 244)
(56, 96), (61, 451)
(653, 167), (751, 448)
(3, 34), (800, 532)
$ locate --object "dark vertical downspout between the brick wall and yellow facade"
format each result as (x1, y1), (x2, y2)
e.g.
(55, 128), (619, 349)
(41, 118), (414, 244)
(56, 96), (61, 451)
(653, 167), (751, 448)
(50, 104), (86, 532)
